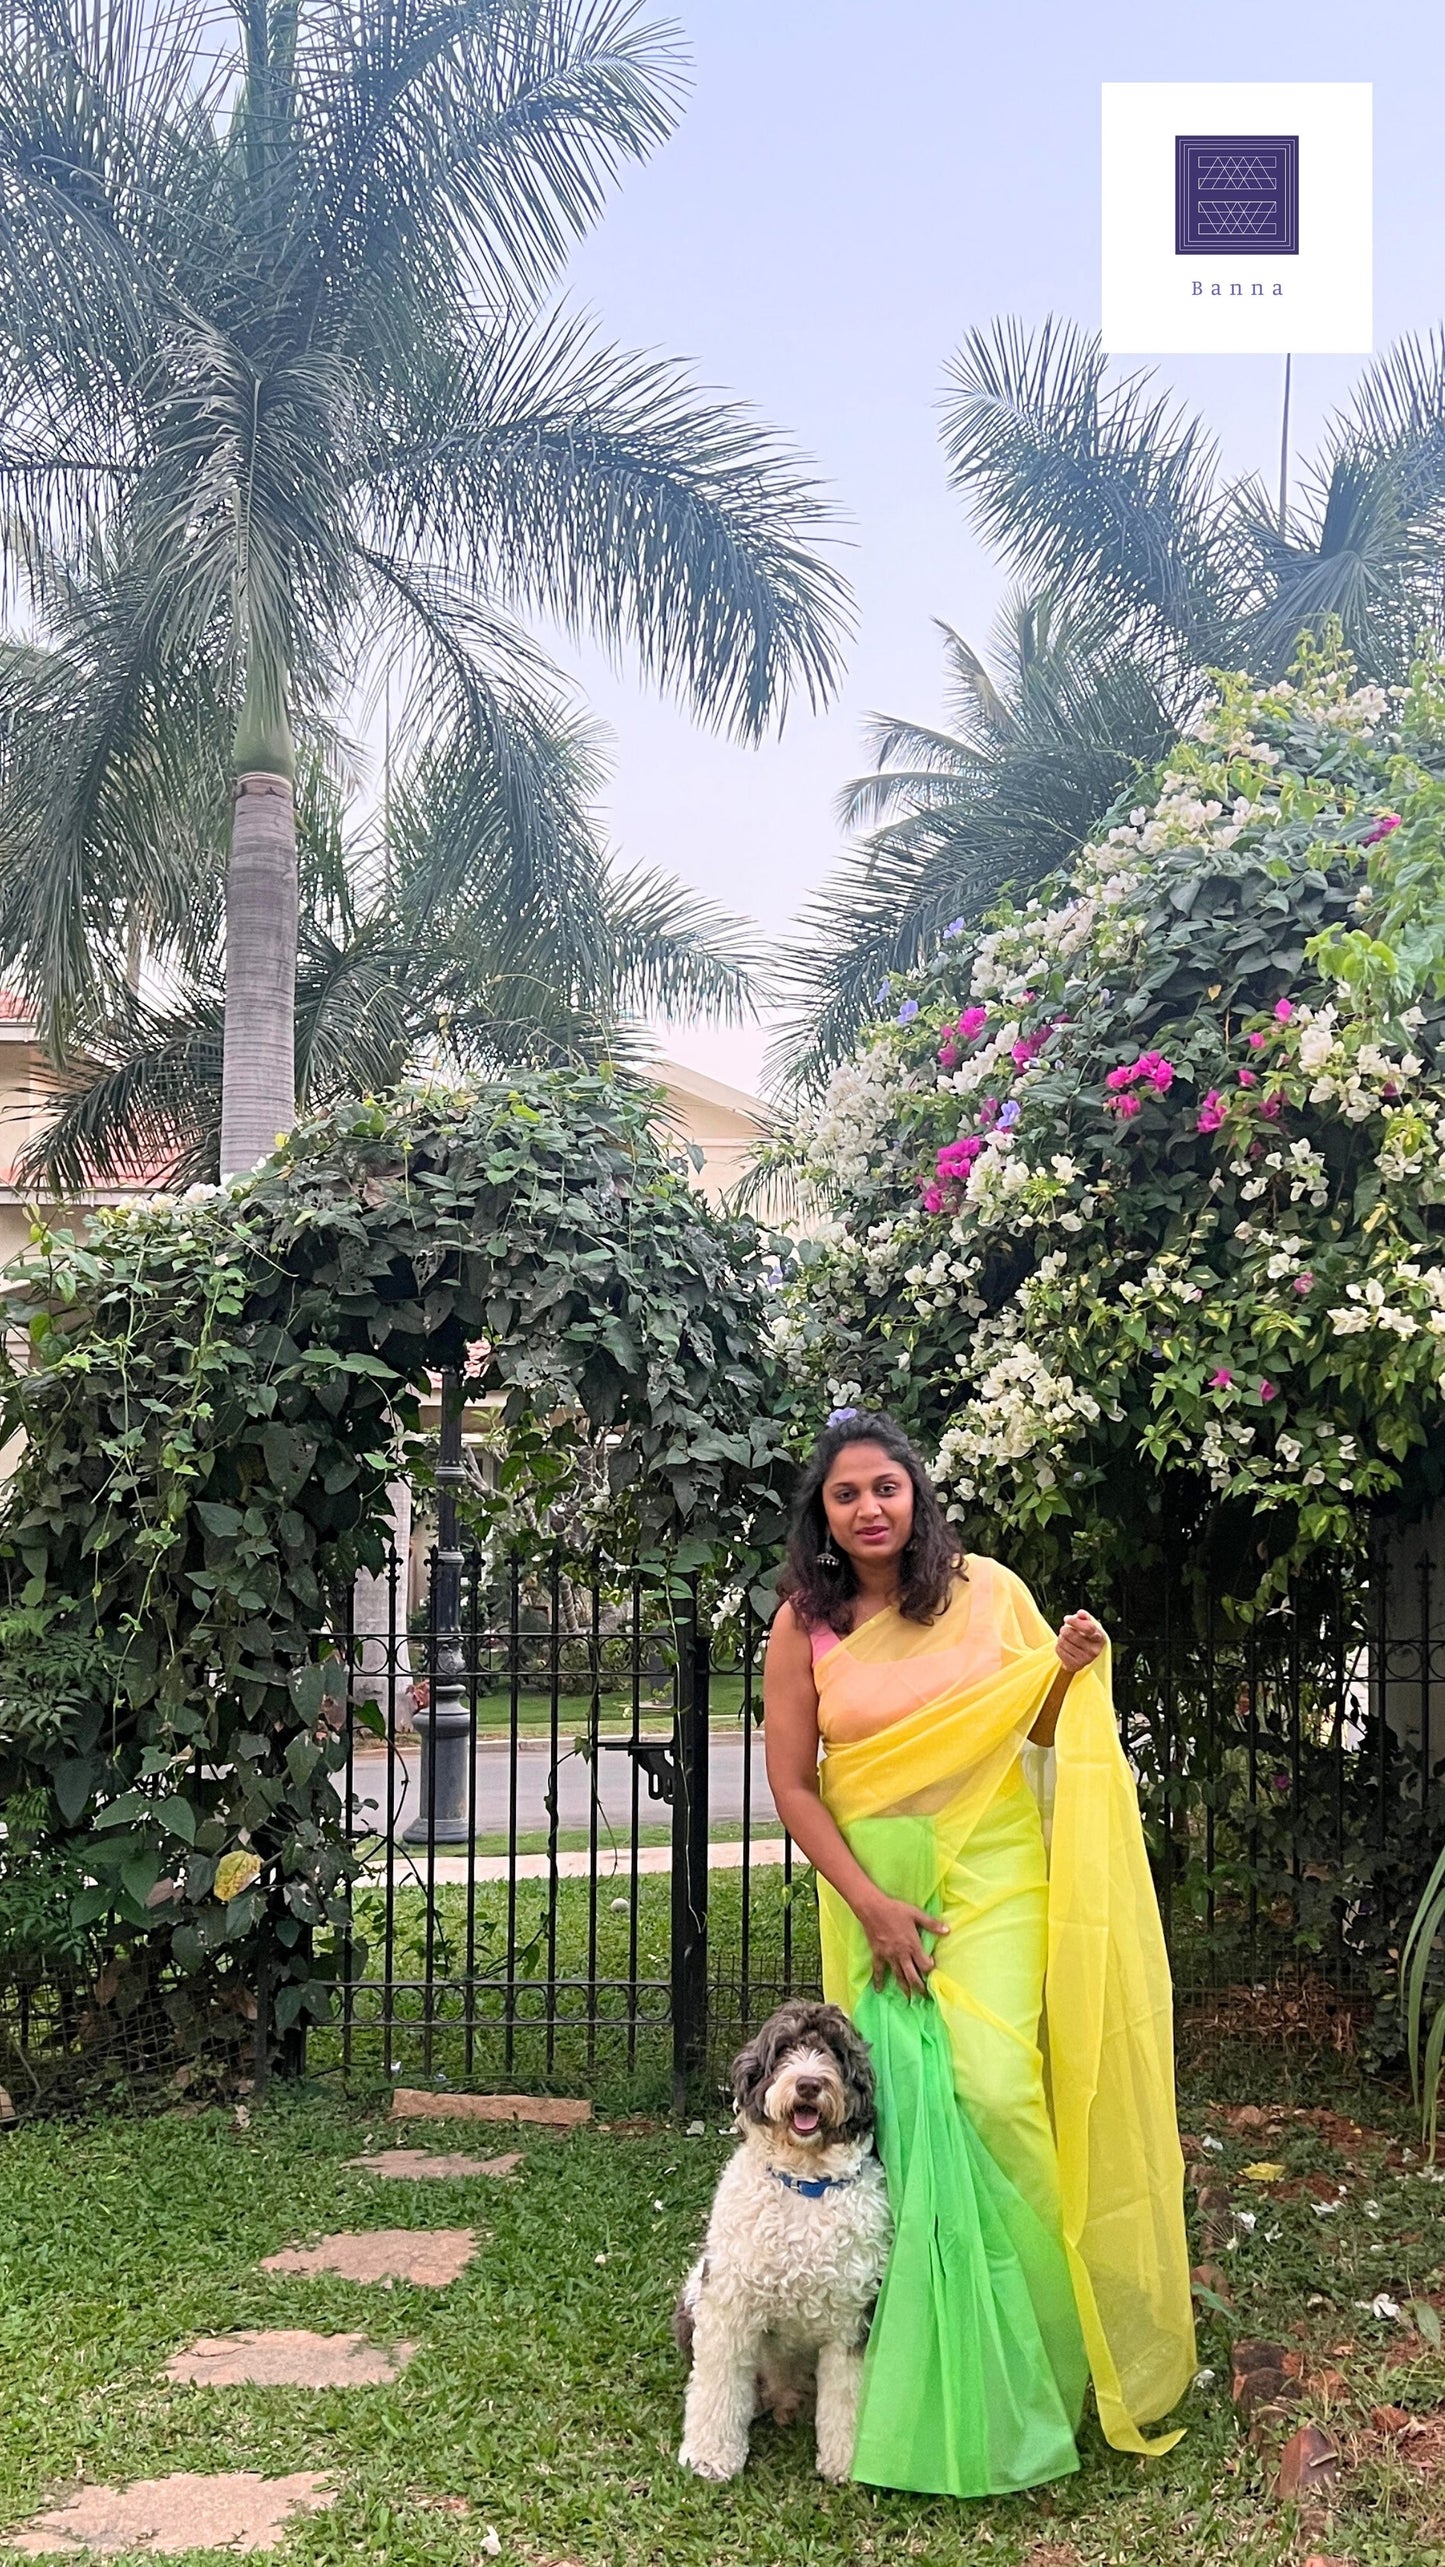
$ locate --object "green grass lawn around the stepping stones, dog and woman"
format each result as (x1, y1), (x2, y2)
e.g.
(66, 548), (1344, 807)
(0, 2046), (1445, 2567)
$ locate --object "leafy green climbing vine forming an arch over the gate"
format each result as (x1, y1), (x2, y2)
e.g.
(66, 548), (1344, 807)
(0, 1073), (785, 2030)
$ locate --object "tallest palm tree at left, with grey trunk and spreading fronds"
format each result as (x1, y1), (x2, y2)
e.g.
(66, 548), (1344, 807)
(0, 0), (844, 1168)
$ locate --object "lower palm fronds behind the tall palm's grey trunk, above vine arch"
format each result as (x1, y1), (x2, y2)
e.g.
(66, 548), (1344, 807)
(11, 667), (755, 1199)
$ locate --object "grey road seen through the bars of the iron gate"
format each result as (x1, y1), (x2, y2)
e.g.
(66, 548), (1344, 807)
(354, 1730), (778, 1843)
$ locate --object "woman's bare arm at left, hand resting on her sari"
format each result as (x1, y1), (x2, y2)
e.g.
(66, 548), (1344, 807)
(762, 1604), (947, 1997)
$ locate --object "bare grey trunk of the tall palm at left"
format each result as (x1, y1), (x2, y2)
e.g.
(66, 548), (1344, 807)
(221, 768), (298, 1176)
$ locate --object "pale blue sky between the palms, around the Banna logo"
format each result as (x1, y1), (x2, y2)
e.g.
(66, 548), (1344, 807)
(526, 0), (1445, 1088)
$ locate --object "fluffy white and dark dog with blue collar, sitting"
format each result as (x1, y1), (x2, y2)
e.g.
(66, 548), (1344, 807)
(672, 2000), (893, 2480)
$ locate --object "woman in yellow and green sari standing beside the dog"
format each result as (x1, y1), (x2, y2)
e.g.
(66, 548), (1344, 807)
(765, 1409), (1193, 2495)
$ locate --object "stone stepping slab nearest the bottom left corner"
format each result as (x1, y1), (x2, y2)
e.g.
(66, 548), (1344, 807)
(5, 2469), (336, 2559)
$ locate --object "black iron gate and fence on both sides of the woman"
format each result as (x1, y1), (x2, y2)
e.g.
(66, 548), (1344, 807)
(322, 1545), (1445, 2097)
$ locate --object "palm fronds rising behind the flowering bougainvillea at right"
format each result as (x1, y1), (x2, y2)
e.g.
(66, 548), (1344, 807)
(773, 321), (1445, 1088)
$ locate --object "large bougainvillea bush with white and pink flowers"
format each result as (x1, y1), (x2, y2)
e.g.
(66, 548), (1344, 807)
(780, 644), (1445, 1599)
